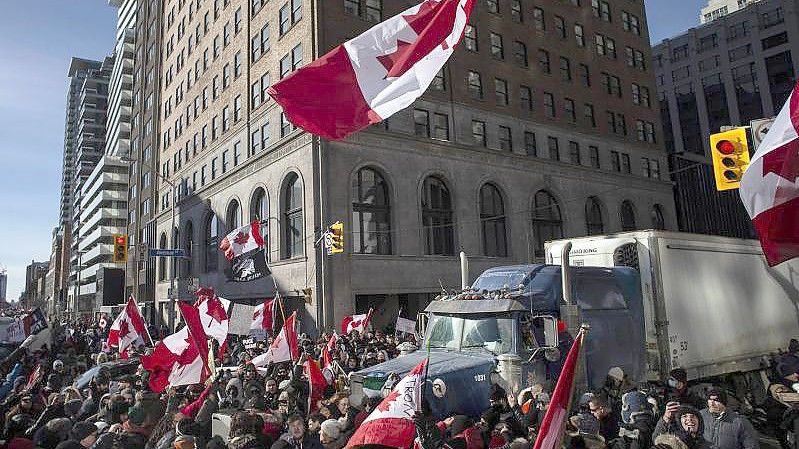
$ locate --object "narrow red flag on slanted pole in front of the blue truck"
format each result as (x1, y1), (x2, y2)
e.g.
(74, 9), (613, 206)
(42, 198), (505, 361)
(533, 332), (585, 449)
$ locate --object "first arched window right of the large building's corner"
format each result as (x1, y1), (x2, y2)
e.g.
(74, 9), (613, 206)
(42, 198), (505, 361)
(352, 168), (391, 254)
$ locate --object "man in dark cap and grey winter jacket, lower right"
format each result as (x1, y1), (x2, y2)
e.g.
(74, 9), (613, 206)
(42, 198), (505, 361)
(701, 388), (760, 449)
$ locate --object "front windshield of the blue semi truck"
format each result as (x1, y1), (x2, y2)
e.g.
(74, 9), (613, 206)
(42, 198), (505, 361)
(427, 315), (513, 355)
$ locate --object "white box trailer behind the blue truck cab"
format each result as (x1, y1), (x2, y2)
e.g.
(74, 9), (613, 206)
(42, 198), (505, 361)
(546, 231), (799, 380)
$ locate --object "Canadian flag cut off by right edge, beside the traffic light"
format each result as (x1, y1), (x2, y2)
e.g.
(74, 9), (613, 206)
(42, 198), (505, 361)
(740, 80), (799, 266)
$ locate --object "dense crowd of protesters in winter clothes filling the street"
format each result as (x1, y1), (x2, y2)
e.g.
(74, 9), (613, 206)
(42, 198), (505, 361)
(6, 316), (799, 449)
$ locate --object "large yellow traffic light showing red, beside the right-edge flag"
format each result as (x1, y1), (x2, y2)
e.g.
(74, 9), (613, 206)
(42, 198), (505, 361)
(710, 128), (749, 190)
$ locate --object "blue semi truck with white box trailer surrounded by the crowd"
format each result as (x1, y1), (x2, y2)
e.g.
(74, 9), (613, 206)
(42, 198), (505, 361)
(350, 231), (799, 417)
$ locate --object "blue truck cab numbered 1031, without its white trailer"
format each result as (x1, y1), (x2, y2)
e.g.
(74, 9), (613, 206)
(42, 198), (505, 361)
(350, 265), (646, 418)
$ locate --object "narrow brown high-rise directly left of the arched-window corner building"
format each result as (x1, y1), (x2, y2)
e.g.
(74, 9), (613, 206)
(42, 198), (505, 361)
(126, 0), (164, 318)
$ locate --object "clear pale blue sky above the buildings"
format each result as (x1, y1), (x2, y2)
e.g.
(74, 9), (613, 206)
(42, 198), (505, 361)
(0, 0), (706, 300)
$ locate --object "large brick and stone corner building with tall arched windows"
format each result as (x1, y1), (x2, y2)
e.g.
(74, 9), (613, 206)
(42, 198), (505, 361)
(153, 0), (676, 329)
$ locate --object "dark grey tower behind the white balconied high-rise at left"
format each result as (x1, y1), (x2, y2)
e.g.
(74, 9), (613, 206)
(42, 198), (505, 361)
(64, 57), (114, 314)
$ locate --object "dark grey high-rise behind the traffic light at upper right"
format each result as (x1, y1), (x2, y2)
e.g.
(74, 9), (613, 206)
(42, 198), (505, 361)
(652, 0), (799, 237)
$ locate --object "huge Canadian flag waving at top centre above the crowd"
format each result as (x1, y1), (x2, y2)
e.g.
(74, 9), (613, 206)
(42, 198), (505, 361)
(268, 0), (474, 140)
